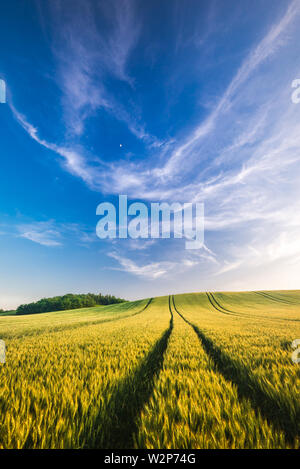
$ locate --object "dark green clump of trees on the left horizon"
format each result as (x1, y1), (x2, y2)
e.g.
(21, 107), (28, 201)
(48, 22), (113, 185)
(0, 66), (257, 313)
(16, 293), (126, 314)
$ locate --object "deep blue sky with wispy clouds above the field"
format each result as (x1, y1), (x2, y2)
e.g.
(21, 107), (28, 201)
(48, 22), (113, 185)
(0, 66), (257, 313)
(0, 0), (300, 308)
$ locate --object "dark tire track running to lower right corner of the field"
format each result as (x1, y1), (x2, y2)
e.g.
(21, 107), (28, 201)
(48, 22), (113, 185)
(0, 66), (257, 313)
(172, 295), (300, 443)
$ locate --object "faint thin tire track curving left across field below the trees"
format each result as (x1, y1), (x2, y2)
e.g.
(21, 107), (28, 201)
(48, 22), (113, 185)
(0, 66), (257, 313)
(1, 298), (154, 340)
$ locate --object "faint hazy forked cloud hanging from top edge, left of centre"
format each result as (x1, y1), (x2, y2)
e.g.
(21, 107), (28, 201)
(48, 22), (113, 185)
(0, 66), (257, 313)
(50, 0), (157, 144)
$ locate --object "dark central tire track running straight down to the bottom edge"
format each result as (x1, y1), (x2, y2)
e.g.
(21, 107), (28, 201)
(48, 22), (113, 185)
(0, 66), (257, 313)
(94, 297), (174, 449)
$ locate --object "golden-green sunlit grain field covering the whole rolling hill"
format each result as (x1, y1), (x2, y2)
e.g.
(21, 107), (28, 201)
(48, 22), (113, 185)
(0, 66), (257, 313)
(0, 291), (300, 449)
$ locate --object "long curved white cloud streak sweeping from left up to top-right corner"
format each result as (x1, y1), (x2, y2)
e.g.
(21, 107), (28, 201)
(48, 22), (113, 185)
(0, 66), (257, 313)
(10, 1), (299, 199)
